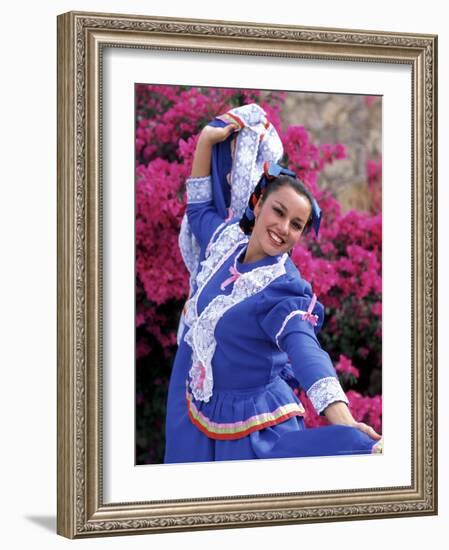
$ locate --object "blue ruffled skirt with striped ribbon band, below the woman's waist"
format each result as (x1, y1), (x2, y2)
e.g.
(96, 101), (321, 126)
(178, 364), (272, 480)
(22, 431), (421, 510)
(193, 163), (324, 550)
(164, 342), (381, 463)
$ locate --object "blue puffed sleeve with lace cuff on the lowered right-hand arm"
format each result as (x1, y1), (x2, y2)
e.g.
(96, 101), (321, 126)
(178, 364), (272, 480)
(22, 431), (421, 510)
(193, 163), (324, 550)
(259, 275), (348, 414)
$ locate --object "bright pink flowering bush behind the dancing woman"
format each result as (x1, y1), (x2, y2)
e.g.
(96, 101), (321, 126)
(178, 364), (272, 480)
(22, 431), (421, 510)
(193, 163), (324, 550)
(136, 85), (382, 463)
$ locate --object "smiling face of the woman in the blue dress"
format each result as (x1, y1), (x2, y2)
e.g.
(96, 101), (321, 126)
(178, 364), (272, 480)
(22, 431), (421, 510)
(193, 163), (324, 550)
(245, 185), (312, 262)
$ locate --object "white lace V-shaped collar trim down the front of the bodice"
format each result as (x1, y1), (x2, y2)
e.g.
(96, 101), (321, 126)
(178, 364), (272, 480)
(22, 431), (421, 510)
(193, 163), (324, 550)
(185, 224), (288, 402)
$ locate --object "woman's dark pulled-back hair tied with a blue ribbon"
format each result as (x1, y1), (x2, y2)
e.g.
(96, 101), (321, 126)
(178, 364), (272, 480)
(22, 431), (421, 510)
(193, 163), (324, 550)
(239, 174), (315, 235)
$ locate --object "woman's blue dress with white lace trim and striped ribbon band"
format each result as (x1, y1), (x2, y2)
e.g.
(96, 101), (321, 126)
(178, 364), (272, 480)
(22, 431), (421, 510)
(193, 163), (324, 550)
(164, 177), (377, 463)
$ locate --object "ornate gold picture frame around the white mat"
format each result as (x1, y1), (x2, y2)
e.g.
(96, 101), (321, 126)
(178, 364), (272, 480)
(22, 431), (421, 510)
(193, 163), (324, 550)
(57, 12), (437, 538)
